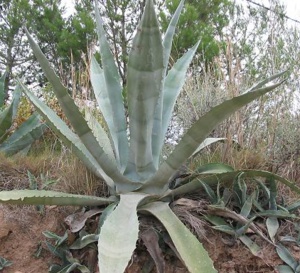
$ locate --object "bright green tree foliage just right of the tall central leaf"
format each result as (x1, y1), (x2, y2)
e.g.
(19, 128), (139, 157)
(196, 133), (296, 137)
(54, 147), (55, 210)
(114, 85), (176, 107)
(160, 0), (233, 63)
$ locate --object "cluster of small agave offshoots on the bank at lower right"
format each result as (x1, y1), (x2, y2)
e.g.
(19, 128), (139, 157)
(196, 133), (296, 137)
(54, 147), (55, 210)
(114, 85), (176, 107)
(204, 171), (300, 266)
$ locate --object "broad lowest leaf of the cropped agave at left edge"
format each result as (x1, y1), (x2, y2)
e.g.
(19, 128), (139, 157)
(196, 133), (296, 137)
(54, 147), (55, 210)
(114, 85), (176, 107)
(0, 113), (47, 156)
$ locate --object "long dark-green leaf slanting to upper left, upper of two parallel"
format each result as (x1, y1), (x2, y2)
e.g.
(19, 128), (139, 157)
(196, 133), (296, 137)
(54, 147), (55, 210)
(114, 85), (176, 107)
(23, 30), (137, 191)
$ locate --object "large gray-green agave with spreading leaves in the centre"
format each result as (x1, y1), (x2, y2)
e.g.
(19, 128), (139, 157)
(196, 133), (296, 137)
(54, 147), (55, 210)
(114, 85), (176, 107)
(0, 0), (294, 273)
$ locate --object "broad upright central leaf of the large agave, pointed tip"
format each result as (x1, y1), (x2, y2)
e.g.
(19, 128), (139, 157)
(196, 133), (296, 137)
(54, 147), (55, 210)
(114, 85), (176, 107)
(126, 0), (164, 180)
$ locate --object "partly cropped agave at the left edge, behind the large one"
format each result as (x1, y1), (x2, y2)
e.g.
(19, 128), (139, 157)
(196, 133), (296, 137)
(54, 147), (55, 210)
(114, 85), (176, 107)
(0, 73), (47, 156)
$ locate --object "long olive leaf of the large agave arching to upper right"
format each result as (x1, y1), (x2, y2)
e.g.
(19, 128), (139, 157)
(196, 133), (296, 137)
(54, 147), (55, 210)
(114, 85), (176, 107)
(143, 73), (288, 192)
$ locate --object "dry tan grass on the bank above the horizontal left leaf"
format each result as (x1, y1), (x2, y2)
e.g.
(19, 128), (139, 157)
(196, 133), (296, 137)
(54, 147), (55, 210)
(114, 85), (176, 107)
(0, 141), (108, 196)
